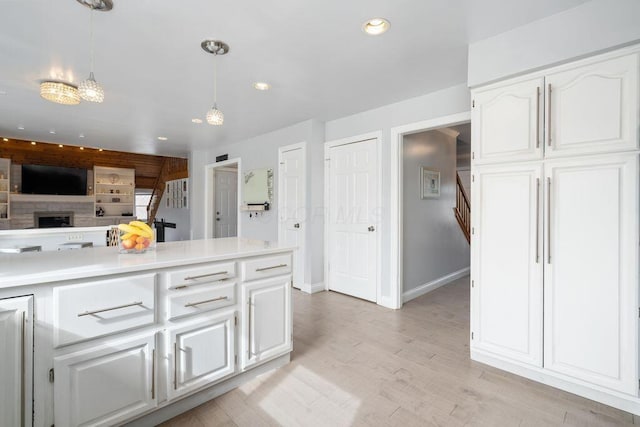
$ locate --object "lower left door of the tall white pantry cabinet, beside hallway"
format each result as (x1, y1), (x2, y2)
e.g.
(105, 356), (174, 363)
(471, 163), (543, 366)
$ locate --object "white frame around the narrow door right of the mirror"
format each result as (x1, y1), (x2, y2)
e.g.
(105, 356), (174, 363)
(278, 141), (311, 293)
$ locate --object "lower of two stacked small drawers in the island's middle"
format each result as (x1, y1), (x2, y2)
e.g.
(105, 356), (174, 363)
(167, 282), (236, 319)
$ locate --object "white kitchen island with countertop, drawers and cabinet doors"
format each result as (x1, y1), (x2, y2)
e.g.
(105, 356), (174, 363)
(0, 238), (293, 427)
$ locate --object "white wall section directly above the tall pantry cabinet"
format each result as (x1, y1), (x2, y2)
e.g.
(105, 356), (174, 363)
(468, 0), (640, 87)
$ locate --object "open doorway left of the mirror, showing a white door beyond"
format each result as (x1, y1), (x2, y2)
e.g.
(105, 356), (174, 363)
(205, 159), (242, 238)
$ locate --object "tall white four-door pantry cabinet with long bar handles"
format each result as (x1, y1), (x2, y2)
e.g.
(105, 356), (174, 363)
(471, 48), (640, 412)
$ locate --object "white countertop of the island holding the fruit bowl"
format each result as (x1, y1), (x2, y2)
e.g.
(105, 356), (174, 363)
(0, 237), (295, 289)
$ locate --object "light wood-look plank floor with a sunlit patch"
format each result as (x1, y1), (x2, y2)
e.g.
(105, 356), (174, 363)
(163, 277), (640, 427)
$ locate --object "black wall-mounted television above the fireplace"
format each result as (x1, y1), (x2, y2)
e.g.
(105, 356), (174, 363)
(22, 165), (87, 196)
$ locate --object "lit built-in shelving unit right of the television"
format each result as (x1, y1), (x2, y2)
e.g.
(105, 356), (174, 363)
(93, 166), (136, 217)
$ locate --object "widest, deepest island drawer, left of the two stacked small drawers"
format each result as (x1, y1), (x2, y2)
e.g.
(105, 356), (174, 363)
(53, 274), (156, 347)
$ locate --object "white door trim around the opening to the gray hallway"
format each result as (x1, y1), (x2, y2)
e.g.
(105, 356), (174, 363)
(388, 111), (471, 309)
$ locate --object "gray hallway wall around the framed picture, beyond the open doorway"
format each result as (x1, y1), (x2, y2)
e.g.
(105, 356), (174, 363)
(402, 131), (469, 293)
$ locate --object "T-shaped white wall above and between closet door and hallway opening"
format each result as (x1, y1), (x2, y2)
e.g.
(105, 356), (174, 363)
(325, 83), (470, 304)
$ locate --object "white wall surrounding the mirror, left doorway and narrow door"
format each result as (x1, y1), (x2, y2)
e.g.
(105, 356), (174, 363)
(189, 120), (324, 285)
